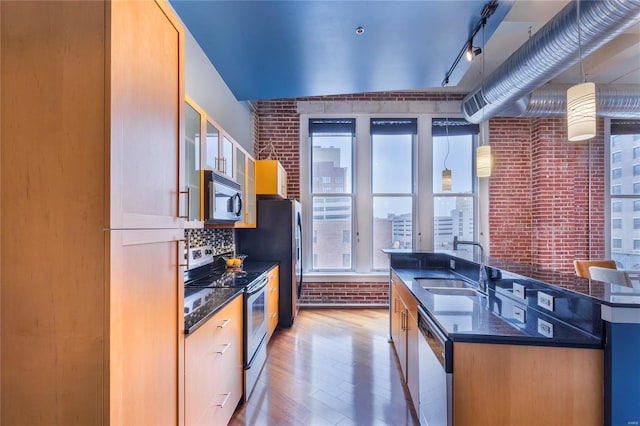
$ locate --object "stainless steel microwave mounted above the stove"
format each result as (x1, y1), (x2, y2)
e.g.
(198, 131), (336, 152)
(204, 170), (244, 223)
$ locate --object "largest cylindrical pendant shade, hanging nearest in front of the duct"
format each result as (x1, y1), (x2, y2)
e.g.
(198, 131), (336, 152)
(567, 83), (596, 142)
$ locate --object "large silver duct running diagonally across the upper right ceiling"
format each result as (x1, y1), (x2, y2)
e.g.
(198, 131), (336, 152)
(462, 0), (640, 123)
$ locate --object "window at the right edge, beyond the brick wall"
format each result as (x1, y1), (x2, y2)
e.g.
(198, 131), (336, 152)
(607, 119), (640, 269)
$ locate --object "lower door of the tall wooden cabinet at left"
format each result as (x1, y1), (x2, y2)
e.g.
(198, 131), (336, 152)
(107, 230), (184, 425)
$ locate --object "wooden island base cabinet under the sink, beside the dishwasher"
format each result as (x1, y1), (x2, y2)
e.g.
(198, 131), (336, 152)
(391, 274), (420, 407)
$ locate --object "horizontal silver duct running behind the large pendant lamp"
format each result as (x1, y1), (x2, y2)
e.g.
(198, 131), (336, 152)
(496, 84), (640, 118)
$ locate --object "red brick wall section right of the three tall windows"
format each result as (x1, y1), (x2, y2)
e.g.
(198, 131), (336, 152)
(489, 118), (604, 273)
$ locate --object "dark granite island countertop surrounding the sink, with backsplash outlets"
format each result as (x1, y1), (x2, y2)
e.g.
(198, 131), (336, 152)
(393, 268), (602, 348)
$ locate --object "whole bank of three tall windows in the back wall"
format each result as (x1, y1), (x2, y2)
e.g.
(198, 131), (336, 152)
(300, 113), (479, 273)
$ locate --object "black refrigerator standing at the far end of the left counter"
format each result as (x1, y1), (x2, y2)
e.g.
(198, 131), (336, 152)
(236, 197), (302, 327)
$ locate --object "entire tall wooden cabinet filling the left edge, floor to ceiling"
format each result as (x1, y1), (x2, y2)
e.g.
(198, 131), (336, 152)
(0, 1), (184, 425)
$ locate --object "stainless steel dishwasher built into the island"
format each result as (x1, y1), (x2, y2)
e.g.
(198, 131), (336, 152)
(418, 306), (453, 426)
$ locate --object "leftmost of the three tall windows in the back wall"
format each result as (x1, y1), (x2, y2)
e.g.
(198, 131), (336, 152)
(309, 118), (355, 270)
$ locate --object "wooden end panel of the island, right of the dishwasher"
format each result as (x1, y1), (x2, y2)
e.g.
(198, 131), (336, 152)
(453, 343), (604, 426)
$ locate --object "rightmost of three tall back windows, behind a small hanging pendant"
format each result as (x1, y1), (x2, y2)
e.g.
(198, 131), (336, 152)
(432, 119), (479, 250)
